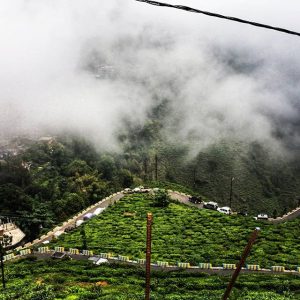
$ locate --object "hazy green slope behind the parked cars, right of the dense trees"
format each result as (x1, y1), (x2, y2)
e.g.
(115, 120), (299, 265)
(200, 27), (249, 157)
(120, 101), (300, 216)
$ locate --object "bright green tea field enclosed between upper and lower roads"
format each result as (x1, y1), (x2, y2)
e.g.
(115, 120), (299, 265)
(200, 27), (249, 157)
(55, 194), (300, 269)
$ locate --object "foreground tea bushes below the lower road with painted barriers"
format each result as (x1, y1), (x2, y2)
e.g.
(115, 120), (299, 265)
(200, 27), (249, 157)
(0, 259), (300, 300)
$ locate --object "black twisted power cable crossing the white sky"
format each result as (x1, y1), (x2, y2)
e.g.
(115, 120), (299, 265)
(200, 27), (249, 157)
(135, 0), (300, 36)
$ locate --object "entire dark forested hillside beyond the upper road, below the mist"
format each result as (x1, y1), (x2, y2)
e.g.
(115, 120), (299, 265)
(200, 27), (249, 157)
(0, 123), (300, 238)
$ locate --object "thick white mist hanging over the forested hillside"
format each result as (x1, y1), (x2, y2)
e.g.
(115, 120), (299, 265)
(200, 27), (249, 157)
(0, 0), (300, 153)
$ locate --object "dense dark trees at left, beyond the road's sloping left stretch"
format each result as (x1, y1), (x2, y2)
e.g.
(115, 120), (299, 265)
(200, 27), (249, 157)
(0, 137), (133, 238)
